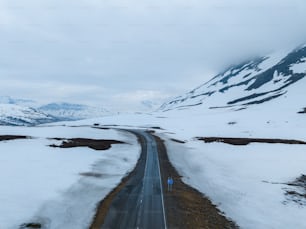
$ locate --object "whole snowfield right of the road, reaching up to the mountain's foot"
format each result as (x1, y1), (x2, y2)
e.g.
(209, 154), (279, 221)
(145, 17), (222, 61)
(61, 76), (306, 229)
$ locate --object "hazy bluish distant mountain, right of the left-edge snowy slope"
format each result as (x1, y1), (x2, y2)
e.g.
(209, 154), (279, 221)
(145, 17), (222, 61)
(38, 103), (111, 120)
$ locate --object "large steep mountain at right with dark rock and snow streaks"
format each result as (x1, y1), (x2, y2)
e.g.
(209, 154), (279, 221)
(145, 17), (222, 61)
(160, 45), (306, 111)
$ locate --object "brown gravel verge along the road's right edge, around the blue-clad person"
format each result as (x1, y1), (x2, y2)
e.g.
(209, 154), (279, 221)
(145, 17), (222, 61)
(155, 136), (239, 229)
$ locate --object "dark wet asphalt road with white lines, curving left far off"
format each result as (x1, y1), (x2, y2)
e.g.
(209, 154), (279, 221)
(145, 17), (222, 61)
(101, 130), (167, 229)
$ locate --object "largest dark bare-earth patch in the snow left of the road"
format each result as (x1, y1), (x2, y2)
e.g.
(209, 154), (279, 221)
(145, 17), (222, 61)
(50, 138), (126, 150)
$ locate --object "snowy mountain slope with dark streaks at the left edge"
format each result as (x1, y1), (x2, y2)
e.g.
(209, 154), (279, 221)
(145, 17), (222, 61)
(0, 104), (57, 126)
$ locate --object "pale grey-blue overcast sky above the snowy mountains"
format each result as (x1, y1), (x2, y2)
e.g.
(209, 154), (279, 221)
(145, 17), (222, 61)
(0, 0), (306, 111)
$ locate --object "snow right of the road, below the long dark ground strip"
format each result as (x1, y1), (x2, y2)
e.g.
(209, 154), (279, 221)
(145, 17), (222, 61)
(166, 140), (306, 229)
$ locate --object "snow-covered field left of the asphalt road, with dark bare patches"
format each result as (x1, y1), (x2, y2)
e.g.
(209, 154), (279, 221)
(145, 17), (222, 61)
(0, 126), (140, 229)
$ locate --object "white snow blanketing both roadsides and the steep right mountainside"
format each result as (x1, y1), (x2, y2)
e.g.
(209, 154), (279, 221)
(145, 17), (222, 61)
(0, 45), (306, 229)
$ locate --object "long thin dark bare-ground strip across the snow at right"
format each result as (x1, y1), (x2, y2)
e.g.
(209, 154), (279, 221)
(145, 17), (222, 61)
(196, 137), (306, 145)
